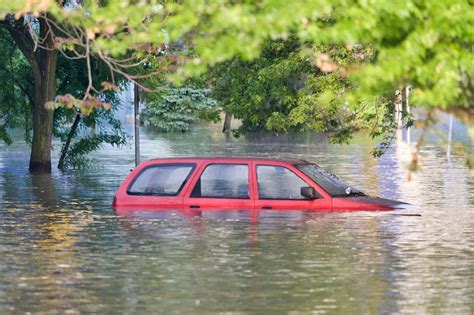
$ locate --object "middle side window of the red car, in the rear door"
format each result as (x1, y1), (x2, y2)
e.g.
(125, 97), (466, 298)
(191, 164), (249, 199)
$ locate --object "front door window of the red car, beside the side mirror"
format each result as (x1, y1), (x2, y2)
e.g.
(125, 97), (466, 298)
(257, 165), (309, 200)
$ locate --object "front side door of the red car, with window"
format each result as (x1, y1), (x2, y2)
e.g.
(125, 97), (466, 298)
(253, 161), (331, 210)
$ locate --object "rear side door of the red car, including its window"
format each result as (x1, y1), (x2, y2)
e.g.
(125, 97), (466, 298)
(183, 160), (254, 210)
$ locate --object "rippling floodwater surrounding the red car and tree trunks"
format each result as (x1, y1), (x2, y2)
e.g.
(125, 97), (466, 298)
(0, 118), (474, 314)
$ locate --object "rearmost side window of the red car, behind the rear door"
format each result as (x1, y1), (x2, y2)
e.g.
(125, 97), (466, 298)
(127, 164), (195, 196)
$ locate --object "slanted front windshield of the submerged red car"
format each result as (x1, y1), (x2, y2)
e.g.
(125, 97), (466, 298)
(295, 164), (365, 197)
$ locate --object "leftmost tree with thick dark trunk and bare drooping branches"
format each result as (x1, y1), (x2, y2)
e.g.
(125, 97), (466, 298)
(0, 1), (169, 173)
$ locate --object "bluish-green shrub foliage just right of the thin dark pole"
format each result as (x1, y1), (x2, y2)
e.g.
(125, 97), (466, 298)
(142, 87), (219, 131)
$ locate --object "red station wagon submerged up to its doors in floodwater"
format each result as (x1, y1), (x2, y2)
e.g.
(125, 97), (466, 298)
(113, 157), (407, 211)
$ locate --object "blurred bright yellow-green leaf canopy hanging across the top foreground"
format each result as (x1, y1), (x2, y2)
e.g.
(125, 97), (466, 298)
(0, 0), (474, 111)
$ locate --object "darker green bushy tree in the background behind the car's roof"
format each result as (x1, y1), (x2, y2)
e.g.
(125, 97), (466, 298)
(204, 38), (362, 132)
